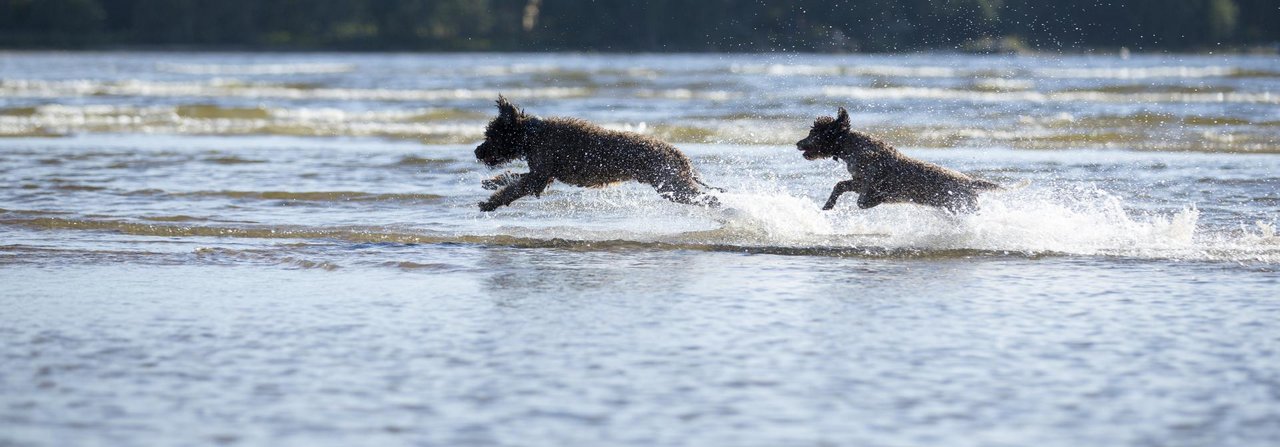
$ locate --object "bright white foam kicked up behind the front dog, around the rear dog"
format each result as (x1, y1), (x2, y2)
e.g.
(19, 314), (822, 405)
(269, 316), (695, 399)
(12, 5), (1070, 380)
(650, 186), (1280, 263)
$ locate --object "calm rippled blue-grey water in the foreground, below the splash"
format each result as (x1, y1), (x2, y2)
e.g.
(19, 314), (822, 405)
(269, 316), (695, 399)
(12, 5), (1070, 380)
(0, 257), (1280, 446)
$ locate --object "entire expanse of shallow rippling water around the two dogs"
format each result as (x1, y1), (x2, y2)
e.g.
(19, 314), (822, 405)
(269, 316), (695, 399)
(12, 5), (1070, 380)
(0, 53), (1280, 446)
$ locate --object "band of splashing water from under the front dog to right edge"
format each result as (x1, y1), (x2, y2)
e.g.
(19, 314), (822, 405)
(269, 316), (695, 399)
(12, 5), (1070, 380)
(481, 176), (1280, 264)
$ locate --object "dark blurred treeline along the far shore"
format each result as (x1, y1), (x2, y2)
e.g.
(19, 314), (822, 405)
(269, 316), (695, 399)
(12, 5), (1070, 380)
(0, 0), (1280, 51)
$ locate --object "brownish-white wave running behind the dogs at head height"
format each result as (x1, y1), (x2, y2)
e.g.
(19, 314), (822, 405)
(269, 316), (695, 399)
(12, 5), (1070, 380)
(0, 104), (1280, 152)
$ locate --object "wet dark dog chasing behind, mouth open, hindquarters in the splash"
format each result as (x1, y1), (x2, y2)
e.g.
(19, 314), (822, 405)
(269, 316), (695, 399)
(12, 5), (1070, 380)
(796, 108), (1001, 214)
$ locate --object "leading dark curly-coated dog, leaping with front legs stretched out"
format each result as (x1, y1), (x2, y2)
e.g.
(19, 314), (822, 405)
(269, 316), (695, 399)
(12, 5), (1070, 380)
(475, 95), (724, 211)
